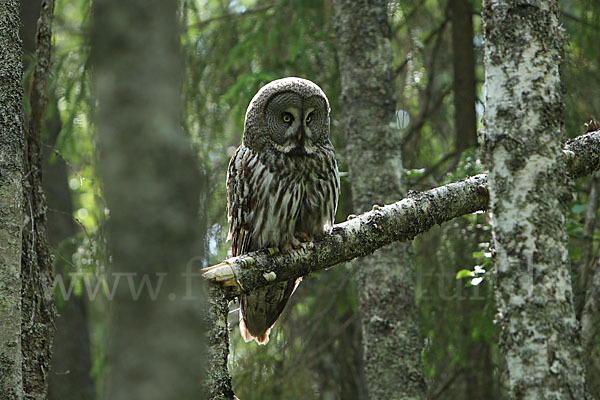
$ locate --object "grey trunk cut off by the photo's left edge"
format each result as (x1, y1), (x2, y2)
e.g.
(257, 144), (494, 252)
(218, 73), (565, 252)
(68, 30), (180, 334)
(0, 0), (25, 400)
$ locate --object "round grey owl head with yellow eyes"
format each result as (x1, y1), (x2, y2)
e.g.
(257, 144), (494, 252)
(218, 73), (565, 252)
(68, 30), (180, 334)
(243, 78), (331, 156)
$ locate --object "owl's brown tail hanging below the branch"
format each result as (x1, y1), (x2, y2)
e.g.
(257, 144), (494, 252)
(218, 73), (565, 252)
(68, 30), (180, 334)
(240, 278), (302, 344)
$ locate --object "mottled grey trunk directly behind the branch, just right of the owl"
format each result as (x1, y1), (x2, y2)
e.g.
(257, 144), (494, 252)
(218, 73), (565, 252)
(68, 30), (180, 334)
(334, 0), (426, 399)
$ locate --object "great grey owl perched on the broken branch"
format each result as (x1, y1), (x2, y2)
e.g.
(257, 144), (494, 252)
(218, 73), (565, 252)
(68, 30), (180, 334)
(227, 78), (340, 344)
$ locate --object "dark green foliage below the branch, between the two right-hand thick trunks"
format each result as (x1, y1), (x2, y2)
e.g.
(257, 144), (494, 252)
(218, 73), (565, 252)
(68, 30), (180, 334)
(415, 213), (501, 398)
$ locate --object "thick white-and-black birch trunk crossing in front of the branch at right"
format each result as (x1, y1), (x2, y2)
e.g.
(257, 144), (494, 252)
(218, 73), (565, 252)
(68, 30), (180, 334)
(482, 0), (586, 399)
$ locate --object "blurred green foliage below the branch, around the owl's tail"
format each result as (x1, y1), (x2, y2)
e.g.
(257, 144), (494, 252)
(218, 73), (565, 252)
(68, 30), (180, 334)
(232, 266), (361, 399)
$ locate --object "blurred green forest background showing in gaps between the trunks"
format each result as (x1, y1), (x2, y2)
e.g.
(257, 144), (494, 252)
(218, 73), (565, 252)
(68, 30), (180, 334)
(36, 0), (600, 400)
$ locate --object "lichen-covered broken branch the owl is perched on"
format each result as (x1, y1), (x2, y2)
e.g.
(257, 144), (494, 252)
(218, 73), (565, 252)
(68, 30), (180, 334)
(203, 131), (600, 296)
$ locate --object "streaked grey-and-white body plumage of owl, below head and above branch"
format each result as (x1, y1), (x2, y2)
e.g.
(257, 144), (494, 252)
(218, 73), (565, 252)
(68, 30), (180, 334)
(228, 145), (339, 252)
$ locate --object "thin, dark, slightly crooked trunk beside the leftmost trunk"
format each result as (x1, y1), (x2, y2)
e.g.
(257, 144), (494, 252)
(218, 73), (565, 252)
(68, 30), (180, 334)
(21, 0), (56, 399)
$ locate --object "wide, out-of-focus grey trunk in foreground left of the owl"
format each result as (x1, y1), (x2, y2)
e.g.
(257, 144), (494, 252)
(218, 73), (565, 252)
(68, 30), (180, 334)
(92, 0), (204, 400)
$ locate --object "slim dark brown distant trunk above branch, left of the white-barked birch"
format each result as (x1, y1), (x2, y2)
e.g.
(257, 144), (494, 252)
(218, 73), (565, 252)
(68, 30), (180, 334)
(448, 0), (477, 152)
